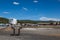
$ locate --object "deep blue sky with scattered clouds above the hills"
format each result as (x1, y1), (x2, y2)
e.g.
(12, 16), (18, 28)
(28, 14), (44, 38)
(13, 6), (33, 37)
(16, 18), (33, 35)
(0, 0), (60, 20)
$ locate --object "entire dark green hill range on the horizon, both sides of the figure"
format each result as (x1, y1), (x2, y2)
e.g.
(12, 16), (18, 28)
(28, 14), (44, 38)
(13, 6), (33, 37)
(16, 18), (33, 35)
(0, 17), (55, 24)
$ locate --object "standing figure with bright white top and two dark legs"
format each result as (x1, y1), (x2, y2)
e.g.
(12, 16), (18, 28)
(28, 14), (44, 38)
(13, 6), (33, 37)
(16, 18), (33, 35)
(9, 18), (21, 36)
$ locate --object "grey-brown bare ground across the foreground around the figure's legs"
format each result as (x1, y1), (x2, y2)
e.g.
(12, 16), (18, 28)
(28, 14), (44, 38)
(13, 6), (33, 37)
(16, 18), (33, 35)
(0, 28), (60, 40)
